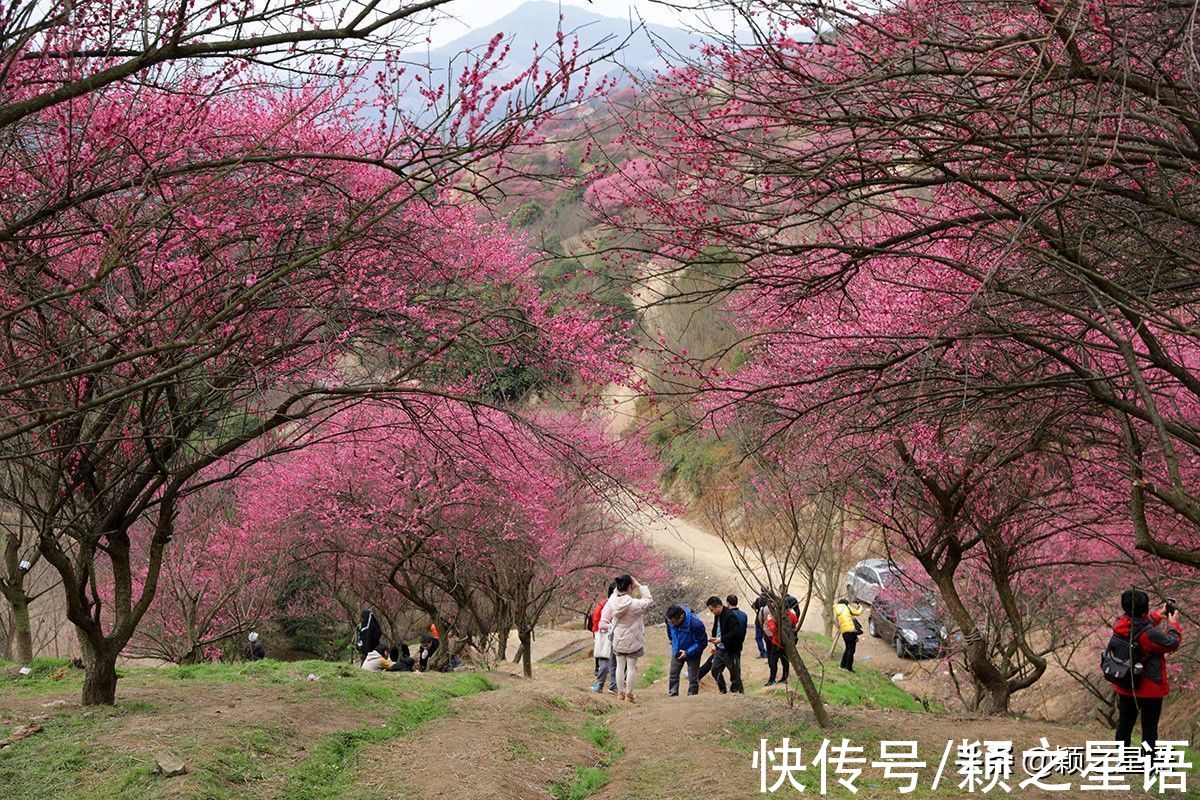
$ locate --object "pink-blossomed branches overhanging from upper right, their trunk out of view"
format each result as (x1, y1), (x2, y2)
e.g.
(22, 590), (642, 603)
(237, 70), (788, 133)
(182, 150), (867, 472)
(606, 0), (1200, 566)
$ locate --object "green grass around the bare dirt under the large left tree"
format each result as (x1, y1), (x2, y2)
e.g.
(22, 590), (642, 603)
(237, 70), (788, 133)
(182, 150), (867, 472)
(0, 662), (494, 800)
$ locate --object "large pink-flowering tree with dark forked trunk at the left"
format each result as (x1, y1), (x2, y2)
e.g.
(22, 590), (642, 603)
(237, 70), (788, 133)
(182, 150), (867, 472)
(0, 2), (620, 703)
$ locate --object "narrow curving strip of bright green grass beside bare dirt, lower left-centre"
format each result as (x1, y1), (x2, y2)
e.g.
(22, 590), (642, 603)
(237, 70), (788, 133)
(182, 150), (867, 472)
(280, 674), (496, 800)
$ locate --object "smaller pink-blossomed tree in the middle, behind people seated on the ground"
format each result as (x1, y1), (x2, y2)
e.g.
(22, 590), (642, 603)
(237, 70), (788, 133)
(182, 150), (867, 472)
(237, 402), (655, 675)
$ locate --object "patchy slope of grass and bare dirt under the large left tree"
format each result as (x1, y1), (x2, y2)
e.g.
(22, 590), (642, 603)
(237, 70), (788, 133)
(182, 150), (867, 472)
(0, 661), (492, 800)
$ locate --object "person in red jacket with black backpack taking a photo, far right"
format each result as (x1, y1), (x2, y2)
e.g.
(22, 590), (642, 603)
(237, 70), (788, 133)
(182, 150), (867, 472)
(1112, 589), (1183, 750)
